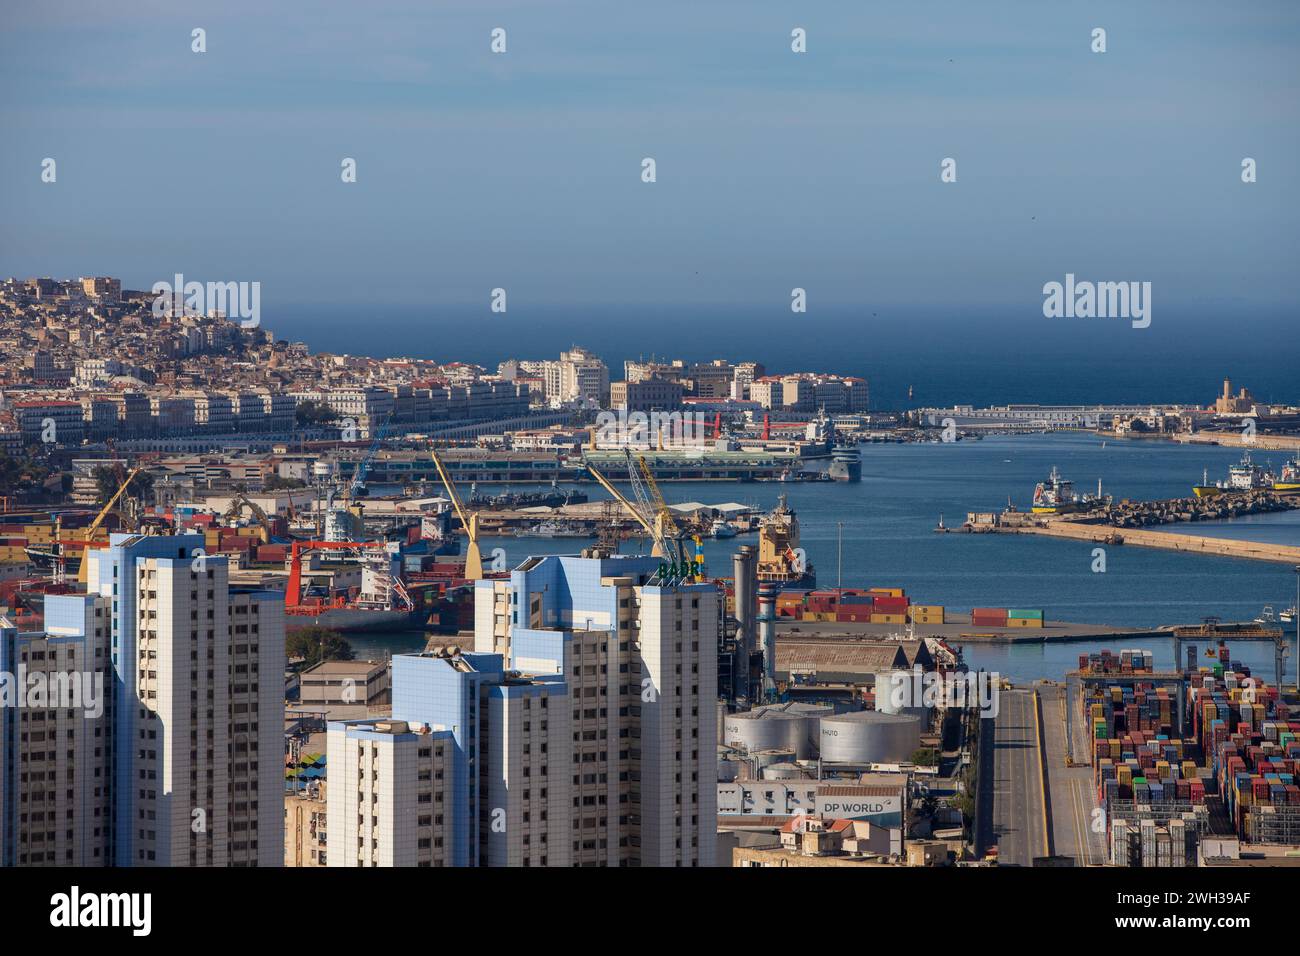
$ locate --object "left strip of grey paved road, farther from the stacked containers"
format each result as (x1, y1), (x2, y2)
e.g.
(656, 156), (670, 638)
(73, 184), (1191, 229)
(992, 691), (1050, 866)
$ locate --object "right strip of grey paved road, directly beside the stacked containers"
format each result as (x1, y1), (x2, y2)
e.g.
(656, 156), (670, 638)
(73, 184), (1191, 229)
(1039, 684), (1106, 866)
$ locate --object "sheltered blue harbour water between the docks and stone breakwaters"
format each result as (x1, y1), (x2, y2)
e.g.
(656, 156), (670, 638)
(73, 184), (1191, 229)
(354, 434), (1300, 679)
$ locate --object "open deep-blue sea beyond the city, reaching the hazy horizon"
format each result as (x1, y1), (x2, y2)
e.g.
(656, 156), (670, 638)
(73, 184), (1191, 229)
(263, 308), (1300, 408)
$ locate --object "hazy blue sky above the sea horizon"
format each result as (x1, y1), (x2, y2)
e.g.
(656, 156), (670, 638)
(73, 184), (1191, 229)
(0, 0), (1300, 325)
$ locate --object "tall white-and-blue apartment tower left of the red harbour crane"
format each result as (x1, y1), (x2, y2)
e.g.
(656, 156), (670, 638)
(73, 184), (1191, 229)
(66, 535), (285, 866)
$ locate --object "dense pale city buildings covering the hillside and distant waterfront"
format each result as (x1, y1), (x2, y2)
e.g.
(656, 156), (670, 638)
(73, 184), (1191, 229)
(0, 277), (867, 453)
